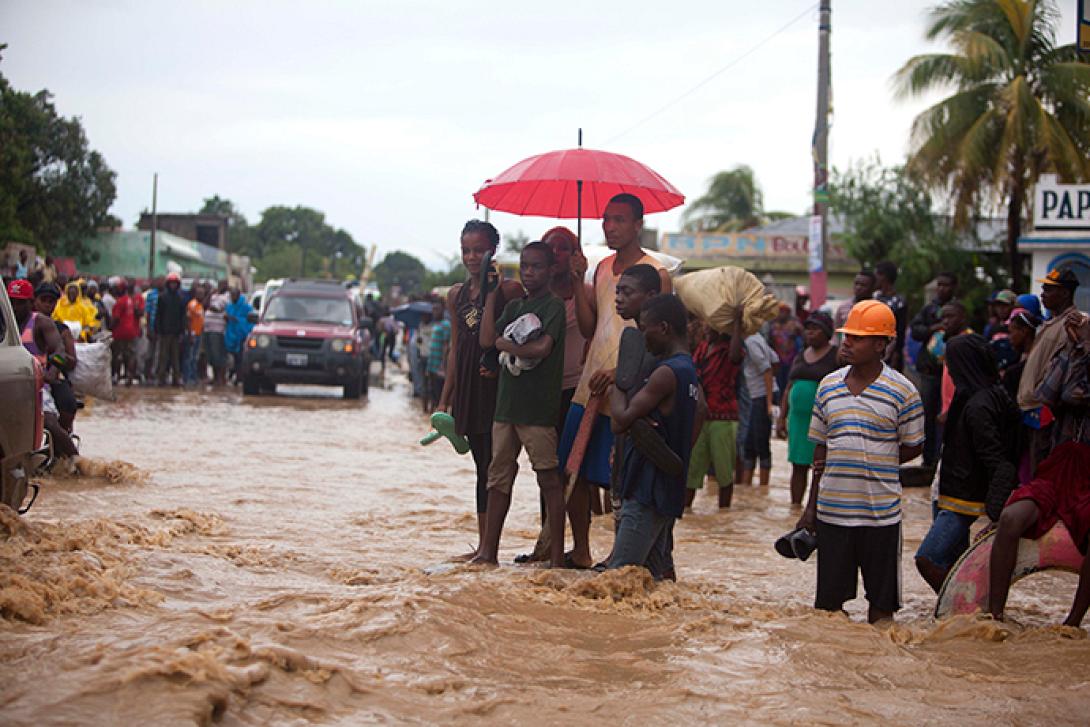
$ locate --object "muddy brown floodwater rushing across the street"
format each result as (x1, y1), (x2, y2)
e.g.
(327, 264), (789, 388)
(0, 375), (1090, 726)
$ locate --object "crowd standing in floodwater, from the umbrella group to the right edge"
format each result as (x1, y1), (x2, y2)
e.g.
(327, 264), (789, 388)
(422, 194), (1090, 626)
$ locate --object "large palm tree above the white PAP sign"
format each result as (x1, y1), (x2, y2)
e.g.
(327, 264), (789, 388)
(894, 0), (1090, 289)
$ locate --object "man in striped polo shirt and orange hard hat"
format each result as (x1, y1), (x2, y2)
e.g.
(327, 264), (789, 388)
(798, 300), (923, 623)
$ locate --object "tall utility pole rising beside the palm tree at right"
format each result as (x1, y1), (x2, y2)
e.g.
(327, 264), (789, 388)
(809, 0), (832, 311)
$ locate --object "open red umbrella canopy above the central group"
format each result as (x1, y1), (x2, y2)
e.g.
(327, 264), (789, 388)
(473, 147), (685, 219)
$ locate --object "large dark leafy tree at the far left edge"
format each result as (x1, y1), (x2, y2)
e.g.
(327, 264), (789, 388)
(0, 57), (121, 262)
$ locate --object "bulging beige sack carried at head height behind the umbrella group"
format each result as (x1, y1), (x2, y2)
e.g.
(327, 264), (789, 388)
(674, 265), (779, 336)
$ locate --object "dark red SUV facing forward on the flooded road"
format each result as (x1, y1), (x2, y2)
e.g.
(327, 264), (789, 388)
(239, 280), (371, 399)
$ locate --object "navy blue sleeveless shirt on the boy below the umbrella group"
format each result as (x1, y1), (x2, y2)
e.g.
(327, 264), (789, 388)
(621, 353), (700, 518)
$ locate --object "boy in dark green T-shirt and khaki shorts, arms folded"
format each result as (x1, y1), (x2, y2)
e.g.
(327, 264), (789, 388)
(472, 242), (566, 568)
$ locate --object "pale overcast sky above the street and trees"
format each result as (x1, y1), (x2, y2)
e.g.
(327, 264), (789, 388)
(0, 0), (1075, 267)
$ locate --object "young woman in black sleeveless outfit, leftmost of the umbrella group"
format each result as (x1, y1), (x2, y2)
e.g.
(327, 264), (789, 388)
(438, 219), (522, 560)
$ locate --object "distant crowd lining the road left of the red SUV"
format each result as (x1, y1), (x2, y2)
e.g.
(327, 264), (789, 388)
(5, 257), (253, 473)
